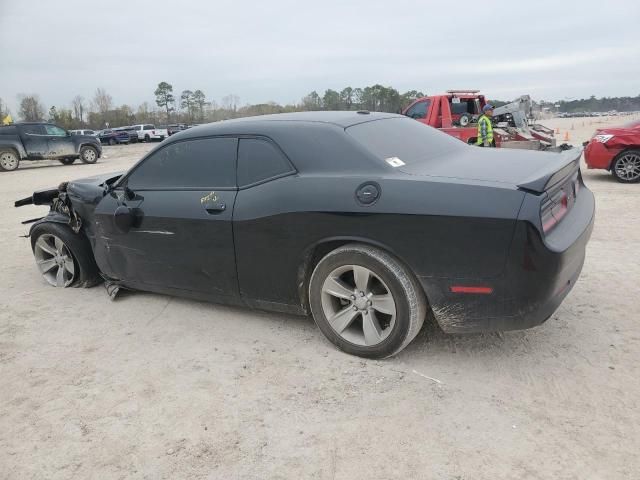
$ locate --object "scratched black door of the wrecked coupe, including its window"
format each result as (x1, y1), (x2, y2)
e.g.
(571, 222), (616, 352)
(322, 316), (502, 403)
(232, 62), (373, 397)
(95, 138), (238, 297)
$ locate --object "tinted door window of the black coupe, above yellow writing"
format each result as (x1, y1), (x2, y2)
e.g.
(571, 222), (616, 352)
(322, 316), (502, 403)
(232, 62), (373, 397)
(127, 138), (237, 191)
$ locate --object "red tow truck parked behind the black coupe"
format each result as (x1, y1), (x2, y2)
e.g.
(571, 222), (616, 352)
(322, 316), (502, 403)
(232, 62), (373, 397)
(402, 90), (570, 151)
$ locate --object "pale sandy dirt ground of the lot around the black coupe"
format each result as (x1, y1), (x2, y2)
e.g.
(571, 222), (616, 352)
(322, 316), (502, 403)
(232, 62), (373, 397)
(0, 117), (640, 480)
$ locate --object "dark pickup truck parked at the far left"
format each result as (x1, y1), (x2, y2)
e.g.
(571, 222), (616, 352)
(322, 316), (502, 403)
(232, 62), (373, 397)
(0, 122), (102, 170)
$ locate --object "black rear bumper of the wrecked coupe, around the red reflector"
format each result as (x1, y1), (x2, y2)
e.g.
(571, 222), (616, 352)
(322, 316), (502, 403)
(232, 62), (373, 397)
(419, 188), (595, 333)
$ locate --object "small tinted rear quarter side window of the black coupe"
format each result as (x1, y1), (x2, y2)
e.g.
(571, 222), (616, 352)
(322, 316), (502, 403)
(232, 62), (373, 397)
(238, 138), (293, 186)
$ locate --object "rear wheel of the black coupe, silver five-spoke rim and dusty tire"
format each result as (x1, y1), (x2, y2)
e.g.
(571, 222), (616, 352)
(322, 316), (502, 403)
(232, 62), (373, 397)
(309, 244), (427, 358)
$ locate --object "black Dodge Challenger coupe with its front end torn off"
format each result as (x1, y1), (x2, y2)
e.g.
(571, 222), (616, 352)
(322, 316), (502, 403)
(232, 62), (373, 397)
(16, 112), (594, 358)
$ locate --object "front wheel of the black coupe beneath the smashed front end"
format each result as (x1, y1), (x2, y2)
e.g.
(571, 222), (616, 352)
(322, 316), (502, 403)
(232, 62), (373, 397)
(31, 222), (100, 288)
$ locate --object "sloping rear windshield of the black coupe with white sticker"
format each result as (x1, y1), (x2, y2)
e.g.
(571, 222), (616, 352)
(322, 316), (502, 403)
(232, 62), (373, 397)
(346, 118), (465, 167)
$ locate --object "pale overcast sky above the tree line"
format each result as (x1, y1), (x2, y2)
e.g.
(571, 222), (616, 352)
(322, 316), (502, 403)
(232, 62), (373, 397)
(0, 0), (640, 112)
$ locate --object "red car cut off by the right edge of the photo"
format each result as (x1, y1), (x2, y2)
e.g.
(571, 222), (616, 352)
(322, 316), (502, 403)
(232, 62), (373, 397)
(584, 120), (640, 183)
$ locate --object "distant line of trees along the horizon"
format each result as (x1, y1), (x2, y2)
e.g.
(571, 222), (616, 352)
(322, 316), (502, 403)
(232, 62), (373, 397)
(0, 81), (640, 129)
